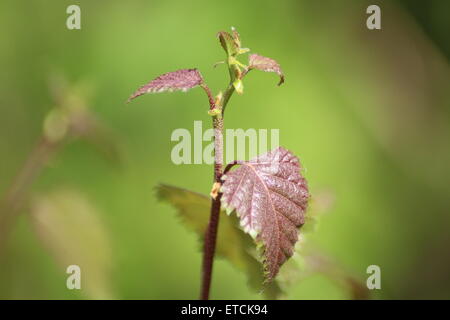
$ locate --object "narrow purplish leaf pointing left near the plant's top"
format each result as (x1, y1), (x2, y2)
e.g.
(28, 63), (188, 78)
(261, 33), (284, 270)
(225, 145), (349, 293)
(128, 69), (203, 102)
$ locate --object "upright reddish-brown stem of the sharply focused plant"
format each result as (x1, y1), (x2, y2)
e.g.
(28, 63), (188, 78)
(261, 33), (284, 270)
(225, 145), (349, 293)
(200, 81), (234, 300)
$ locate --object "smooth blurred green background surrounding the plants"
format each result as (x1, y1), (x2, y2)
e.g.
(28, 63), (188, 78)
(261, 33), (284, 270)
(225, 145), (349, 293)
(0, 0), (450, 299)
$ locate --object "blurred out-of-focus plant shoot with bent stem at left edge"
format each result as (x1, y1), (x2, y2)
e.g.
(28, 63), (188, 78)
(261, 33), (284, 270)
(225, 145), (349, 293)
(0, 77), (120, 256)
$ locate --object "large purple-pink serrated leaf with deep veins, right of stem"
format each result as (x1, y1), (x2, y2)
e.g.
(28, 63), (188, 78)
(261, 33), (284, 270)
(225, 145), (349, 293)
(221, 147), (309, 281)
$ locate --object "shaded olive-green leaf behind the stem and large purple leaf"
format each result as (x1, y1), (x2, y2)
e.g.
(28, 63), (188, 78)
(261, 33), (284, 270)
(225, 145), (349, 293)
(156, 184), (282, 299)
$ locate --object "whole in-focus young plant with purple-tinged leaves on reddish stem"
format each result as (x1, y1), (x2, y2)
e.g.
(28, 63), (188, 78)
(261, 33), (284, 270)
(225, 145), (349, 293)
(128, 28), (310, 299)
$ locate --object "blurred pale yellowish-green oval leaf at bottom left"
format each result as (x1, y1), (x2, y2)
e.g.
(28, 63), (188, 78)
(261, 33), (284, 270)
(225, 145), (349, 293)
(30, 190), (113, 299)
